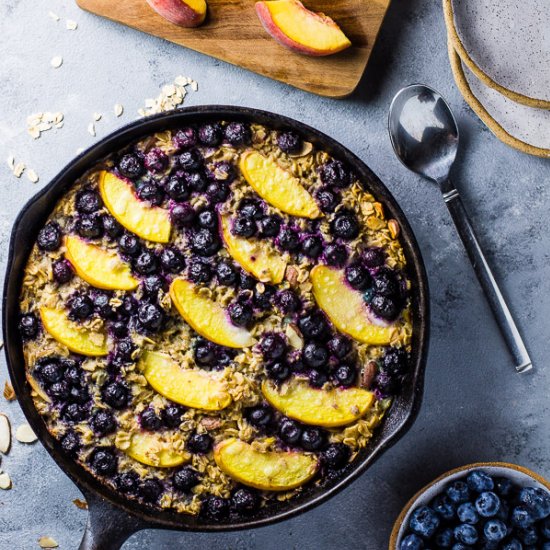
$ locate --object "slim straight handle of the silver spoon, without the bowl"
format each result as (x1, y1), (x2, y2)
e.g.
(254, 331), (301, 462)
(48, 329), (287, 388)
(441, 180), (533, 372)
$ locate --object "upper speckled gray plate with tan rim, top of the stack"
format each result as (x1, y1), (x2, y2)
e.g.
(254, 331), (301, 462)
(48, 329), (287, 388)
(443, 0), (550, 109)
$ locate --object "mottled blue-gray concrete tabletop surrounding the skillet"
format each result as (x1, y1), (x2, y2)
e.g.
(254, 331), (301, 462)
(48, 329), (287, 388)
(0, 0), (550, 550)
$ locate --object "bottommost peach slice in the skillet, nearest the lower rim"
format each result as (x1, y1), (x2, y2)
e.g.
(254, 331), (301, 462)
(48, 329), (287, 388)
(214, 438), (319, 491)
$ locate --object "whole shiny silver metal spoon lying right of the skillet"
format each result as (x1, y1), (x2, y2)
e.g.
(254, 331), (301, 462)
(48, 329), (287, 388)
(388, 84), (533, 372)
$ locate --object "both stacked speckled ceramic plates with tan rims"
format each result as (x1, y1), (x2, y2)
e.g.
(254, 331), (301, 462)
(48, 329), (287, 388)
(443, 0), (550, 158)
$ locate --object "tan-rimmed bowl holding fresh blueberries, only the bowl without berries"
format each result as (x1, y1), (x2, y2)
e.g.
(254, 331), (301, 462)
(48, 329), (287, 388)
(389, 462), (550, 550)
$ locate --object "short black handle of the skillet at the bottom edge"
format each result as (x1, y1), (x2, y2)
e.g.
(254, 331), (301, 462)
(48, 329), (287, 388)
(79, 492), (148, 550)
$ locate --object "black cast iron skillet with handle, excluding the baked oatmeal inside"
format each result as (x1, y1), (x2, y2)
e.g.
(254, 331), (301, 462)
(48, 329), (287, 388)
(3, 106), (429, 550)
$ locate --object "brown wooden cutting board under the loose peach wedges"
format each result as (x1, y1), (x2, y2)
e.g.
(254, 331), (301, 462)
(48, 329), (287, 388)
(77, 0), (390, 97)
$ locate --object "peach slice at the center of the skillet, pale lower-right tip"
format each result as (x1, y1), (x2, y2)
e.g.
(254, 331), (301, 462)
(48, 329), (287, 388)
(170, 279), (256, 348)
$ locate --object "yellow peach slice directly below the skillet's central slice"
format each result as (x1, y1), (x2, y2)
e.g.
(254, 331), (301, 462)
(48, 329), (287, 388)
(139, 351), (231, 411)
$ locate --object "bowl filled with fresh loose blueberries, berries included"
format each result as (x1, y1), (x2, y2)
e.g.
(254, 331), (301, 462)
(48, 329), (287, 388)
(389, 462), (550, 550)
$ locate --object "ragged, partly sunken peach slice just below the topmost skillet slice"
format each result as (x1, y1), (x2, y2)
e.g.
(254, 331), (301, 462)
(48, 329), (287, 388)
(220, 216), (286, 284)
